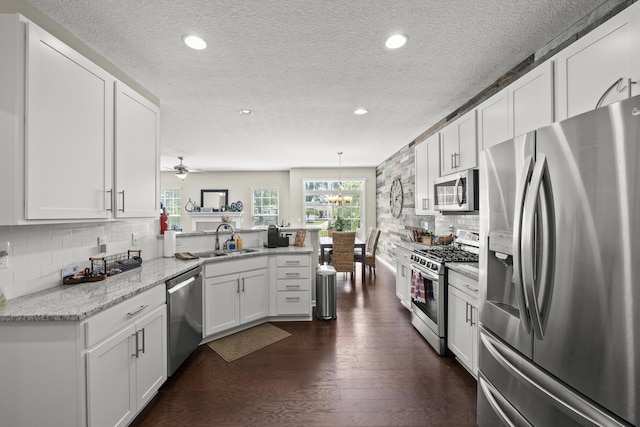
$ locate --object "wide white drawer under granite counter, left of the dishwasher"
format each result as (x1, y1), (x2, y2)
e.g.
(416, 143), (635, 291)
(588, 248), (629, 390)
(84, 285), (166, 348)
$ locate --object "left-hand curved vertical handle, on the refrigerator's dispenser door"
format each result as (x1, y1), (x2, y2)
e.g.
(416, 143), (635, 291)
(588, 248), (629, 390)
(513, 156), (533, 334)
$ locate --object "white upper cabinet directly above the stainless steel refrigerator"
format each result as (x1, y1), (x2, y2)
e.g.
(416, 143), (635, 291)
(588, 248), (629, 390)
(556, 3), (640, 120)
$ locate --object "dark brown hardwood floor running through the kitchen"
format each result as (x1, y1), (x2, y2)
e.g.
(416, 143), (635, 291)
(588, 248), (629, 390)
(132, 263), (476, 427)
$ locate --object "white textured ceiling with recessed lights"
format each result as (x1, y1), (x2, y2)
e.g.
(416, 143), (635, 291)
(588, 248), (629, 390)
(29, 0), (602, 170)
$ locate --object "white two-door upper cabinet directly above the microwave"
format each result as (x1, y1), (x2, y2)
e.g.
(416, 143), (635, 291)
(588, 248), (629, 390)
(440, 109), (478, 176)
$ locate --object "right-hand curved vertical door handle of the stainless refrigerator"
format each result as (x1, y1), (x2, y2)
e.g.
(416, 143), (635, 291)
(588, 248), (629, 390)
(521, 153), (552, 340)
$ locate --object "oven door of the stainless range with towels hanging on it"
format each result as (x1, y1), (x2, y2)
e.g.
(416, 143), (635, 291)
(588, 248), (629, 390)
(411, 264), (446, 338)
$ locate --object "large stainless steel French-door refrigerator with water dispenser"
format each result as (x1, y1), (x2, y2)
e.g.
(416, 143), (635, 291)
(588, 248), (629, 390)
(478, 97), (640, 427)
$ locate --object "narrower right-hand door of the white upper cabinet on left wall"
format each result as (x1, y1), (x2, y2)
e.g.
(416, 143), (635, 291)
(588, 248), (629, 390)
(115, 82), (160, 218)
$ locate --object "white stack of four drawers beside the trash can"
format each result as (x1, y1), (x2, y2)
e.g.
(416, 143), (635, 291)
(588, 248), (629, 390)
(276, 255), (311, 316)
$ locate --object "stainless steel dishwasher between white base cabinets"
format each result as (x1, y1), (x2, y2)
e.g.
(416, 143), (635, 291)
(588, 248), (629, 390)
(167, 267), (202, 376)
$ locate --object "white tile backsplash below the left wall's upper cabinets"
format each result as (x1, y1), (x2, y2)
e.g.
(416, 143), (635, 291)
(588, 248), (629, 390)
(0, 219), (162, 299)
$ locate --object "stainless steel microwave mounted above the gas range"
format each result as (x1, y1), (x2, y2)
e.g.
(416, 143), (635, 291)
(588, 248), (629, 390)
(433, 169), (478, 212)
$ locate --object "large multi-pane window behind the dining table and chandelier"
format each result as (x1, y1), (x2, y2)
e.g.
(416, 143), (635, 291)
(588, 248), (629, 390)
(304, 180), (364, 231)
